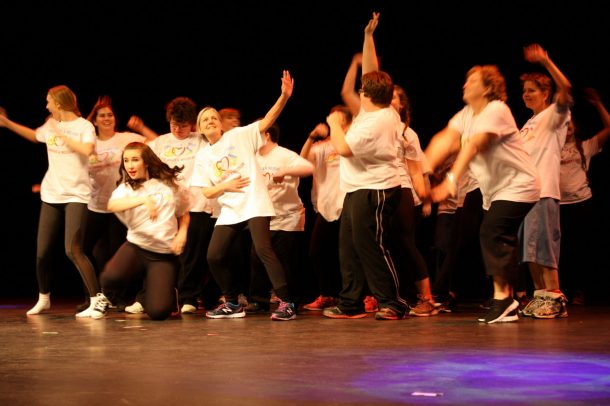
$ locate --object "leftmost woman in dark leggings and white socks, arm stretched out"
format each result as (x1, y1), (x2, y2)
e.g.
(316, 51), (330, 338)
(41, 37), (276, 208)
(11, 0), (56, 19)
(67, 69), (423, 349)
(0, 85), (100, 315)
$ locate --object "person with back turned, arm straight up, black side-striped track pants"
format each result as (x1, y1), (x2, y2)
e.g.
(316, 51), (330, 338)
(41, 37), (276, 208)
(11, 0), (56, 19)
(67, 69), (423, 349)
(322, 13), (408, 320)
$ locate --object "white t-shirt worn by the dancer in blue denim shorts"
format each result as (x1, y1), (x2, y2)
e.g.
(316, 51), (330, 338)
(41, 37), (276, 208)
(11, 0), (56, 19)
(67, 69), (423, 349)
(520, 103), (570, 200)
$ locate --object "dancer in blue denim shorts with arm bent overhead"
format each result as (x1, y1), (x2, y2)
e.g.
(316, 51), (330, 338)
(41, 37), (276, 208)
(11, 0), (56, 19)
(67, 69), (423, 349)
(520, 44), (572, 319)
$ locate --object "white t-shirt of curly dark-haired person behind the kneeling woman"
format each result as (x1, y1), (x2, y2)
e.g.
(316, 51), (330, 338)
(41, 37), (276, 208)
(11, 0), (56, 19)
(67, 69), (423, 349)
(148, 132), (218, 213)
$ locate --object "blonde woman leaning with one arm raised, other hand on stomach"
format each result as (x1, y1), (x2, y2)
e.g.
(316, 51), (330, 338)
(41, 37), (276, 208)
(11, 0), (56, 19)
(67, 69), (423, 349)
(191, 71), (296, 320)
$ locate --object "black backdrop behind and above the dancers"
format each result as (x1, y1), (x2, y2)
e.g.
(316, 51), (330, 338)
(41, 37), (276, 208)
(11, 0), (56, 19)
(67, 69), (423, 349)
(0, 0), (610, 302)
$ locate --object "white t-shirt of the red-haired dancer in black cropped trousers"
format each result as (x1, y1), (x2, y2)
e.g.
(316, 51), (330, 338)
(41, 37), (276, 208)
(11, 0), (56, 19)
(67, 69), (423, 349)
(449, 100), (540, 210)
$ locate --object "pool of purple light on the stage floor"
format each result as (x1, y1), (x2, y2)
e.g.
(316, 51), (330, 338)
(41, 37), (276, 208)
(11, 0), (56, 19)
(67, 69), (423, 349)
(353, 349), (610, 404)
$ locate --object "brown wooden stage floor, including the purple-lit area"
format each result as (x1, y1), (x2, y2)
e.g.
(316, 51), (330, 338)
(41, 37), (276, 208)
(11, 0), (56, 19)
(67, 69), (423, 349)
(0, 298), (610, 406)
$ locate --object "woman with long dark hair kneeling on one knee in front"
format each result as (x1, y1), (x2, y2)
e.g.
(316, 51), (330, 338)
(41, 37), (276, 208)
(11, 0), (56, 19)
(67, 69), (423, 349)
(91, 142), (190, 320)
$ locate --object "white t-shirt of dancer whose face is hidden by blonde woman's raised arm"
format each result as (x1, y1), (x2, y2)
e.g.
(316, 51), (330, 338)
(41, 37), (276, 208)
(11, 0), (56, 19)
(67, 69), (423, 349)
(256, 145), (313, 231)
